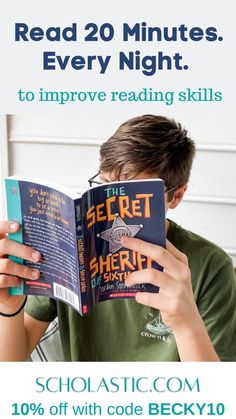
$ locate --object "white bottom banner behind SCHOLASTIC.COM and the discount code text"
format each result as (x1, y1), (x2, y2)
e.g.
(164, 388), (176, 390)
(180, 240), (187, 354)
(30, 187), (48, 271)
(0, 362), (236, 419)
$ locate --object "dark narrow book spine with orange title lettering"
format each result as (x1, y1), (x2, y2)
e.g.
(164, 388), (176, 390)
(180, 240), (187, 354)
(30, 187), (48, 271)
(76, 199), (90, 316)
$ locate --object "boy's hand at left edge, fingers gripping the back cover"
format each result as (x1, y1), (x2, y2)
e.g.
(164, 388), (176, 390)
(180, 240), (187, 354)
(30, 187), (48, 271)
(0, 221), (41, 313)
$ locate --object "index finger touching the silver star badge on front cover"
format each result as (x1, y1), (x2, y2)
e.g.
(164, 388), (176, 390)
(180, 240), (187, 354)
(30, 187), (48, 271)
(121, 236), (181, 269)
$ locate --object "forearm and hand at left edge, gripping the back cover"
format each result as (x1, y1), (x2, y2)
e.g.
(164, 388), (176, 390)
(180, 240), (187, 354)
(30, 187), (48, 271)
(0, 221), (48, 361)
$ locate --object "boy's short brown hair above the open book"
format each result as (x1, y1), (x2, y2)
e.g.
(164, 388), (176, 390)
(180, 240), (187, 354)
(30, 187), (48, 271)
(100, 115), (195, 198)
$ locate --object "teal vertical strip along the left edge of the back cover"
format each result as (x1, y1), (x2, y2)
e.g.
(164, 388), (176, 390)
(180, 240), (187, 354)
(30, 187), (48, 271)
(5, 179), (24, 295)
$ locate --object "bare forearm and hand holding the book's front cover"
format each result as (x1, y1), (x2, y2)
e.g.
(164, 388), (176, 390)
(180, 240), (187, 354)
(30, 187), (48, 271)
(121, 236), (219, 361)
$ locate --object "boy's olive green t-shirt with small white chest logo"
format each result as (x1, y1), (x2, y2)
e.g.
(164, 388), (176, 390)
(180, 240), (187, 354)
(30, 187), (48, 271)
(26, 221), (236, 361)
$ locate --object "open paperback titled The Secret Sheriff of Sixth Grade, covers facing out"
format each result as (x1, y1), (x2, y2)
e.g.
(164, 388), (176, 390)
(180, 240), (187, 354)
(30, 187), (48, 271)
(5, 176), (166, 316)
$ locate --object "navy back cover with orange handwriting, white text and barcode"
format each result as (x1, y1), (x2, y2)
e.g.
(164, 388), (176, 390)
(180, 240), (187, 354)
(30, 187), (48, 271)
(6, 179), (79, 309)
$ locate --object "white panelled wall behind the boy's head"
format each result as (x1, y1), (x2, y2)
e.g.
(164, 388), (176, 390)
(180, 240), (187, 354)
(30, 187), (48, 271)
(0, 115), (236, 265)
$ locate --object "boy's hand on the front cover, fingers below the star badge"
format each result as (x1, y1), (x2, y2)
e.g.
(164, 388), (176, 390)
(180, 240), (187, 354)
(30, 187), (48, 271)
(121, 236), (201, 334)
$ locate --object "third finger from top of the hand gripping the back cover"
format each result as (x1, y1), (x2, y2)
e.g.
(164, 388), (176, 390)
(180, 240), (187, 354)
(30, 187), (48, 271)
(0, 259), (40, 279)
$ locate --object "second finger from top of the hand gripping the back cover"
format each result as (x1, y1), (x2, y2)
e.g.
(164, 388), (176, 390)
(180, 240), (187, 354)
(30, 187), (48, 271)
(0, 237), (41, 262)
